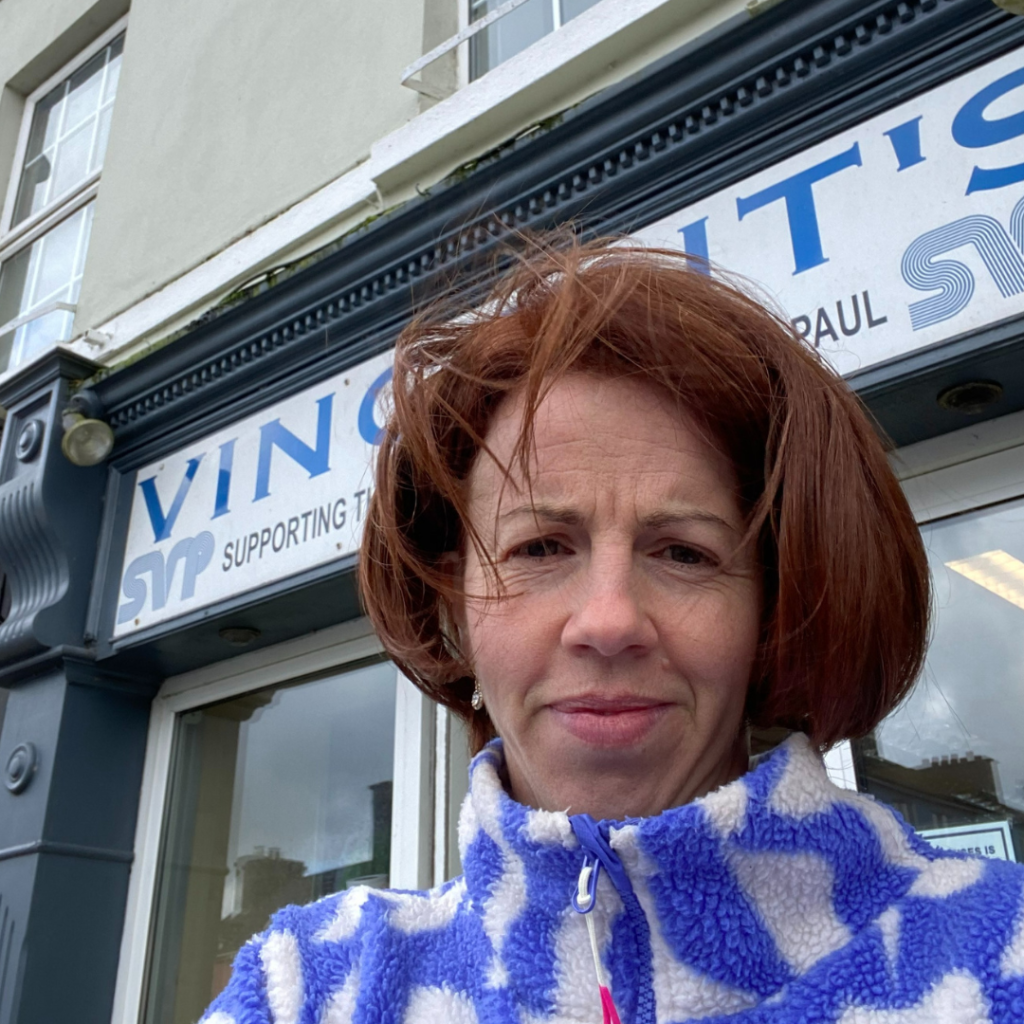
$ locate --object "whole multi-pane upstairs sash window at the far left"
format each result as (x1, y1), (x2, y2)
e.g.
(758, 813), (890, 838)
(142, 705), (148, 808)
(0, 25), (124, 372)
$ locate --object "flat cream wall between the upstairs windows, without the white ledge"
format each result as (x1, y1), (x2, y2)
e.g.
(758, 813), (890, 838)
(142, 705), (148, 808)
(74, 0), (424, 330)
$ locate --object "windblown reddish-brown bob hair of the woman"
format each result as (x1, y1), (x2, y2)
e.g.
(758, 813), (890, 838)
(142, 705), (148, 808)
(359, 240), (929, 751)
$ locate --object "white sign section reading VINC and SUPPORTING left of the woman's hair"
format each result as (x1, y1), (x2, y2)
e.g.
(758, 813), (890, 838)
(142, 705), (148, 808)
(114, 352), (393, 637)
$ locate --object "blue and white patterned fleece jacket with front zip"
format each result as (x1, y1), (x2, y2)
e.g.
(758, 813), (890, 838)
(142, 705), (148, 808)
(204, 735), (1024, 1024)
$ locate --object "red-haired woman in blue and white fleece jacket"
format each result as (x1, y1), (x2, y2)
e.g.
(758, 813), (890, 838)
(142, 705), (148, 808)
(206, 244), (1024, 1024)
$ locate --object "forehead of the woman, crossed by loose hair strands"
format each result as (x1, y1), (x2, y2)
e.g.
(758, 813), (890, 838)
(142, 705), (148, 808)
(470, 373), (737, 503)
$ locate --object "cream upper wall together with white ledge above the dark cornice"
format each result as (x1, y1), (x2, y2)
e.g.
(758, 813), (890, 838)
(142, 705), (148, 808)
(0, 0), (748, 366)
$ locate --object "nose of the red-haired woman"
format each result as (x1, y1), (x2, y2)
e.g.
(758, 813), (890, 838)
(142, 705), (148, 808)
(561, 557), (656, 657)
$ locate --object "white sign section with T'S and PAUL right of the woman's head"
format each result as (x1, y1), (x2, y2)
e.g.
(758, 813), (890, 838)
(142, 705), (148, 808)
(638, 49), (1024, 374)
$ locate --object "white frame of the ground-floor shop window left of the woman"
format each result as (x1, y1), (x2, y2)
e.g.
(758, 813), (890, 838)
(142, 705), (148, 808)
(111, 618), (443, 1024)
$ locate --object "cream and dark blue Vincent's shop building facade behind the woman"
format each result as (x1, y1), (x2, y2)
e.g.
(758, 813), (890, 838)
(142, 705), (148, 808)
(0, 0), (1024, 1024)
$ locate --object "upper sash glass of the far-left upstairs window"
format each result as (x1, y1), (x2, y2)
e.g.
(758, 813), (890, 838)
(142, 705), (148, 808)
(11, 35), (124, 225)
